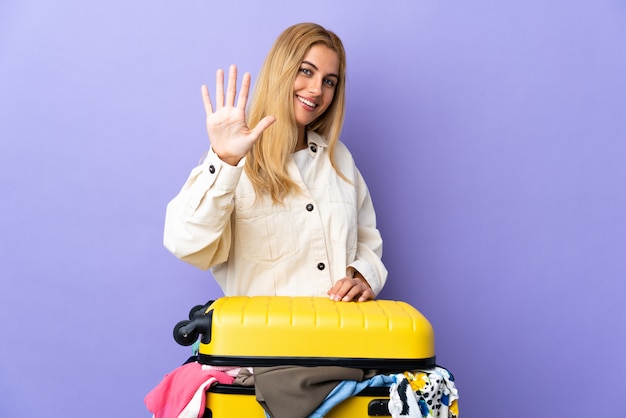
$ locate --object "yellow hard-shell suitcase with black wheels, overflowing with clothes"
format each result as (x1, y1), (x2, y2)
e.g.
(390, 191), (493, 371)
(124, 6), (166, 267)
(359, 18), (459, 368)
(174, 296), (435, 418)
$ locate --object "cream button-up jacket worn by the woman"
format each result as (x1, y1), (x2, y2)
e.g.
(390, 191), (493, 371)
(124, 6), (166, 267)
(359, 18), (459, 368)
(164, 131), (387, 296)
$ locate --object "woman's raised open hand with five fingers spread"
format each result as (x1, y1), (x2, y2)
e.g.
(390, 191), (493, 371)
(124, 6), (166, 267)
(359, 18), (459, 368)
(201, 65), (276, 165)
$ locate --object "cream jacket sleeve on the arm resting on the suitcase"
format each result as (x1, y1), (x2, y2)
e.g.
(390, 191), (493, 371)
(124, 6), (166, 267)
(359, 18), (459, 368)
(348, 167), (387, 295)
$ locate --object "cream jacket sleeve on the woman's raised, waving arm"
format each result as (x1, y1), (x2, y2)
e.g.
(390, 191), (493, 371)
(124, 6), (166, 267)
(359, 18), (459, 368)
(163, 150), (244, 270)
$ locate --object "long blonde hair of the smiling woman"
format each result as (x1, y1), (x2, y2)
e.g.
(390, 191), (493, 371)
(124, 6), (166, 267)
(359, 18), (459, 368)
(245, 23), (347, 203)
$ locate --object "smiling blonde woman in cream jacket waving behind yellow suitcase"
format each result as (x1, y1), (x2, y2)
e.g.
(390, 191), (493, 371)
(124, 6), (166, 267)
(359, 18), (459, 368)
(164, 23), (387, 301)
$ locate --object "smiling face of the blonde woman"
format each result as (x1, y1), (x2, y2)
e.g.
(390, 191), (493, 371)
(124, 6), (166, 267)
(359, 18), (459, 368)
(293, 44), (339, 128)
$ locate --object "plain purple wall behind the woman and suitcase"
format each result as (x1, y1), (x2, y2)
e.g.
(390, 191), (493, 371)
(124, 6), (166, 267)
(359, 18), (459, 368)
(0, 0), (626, 418)
